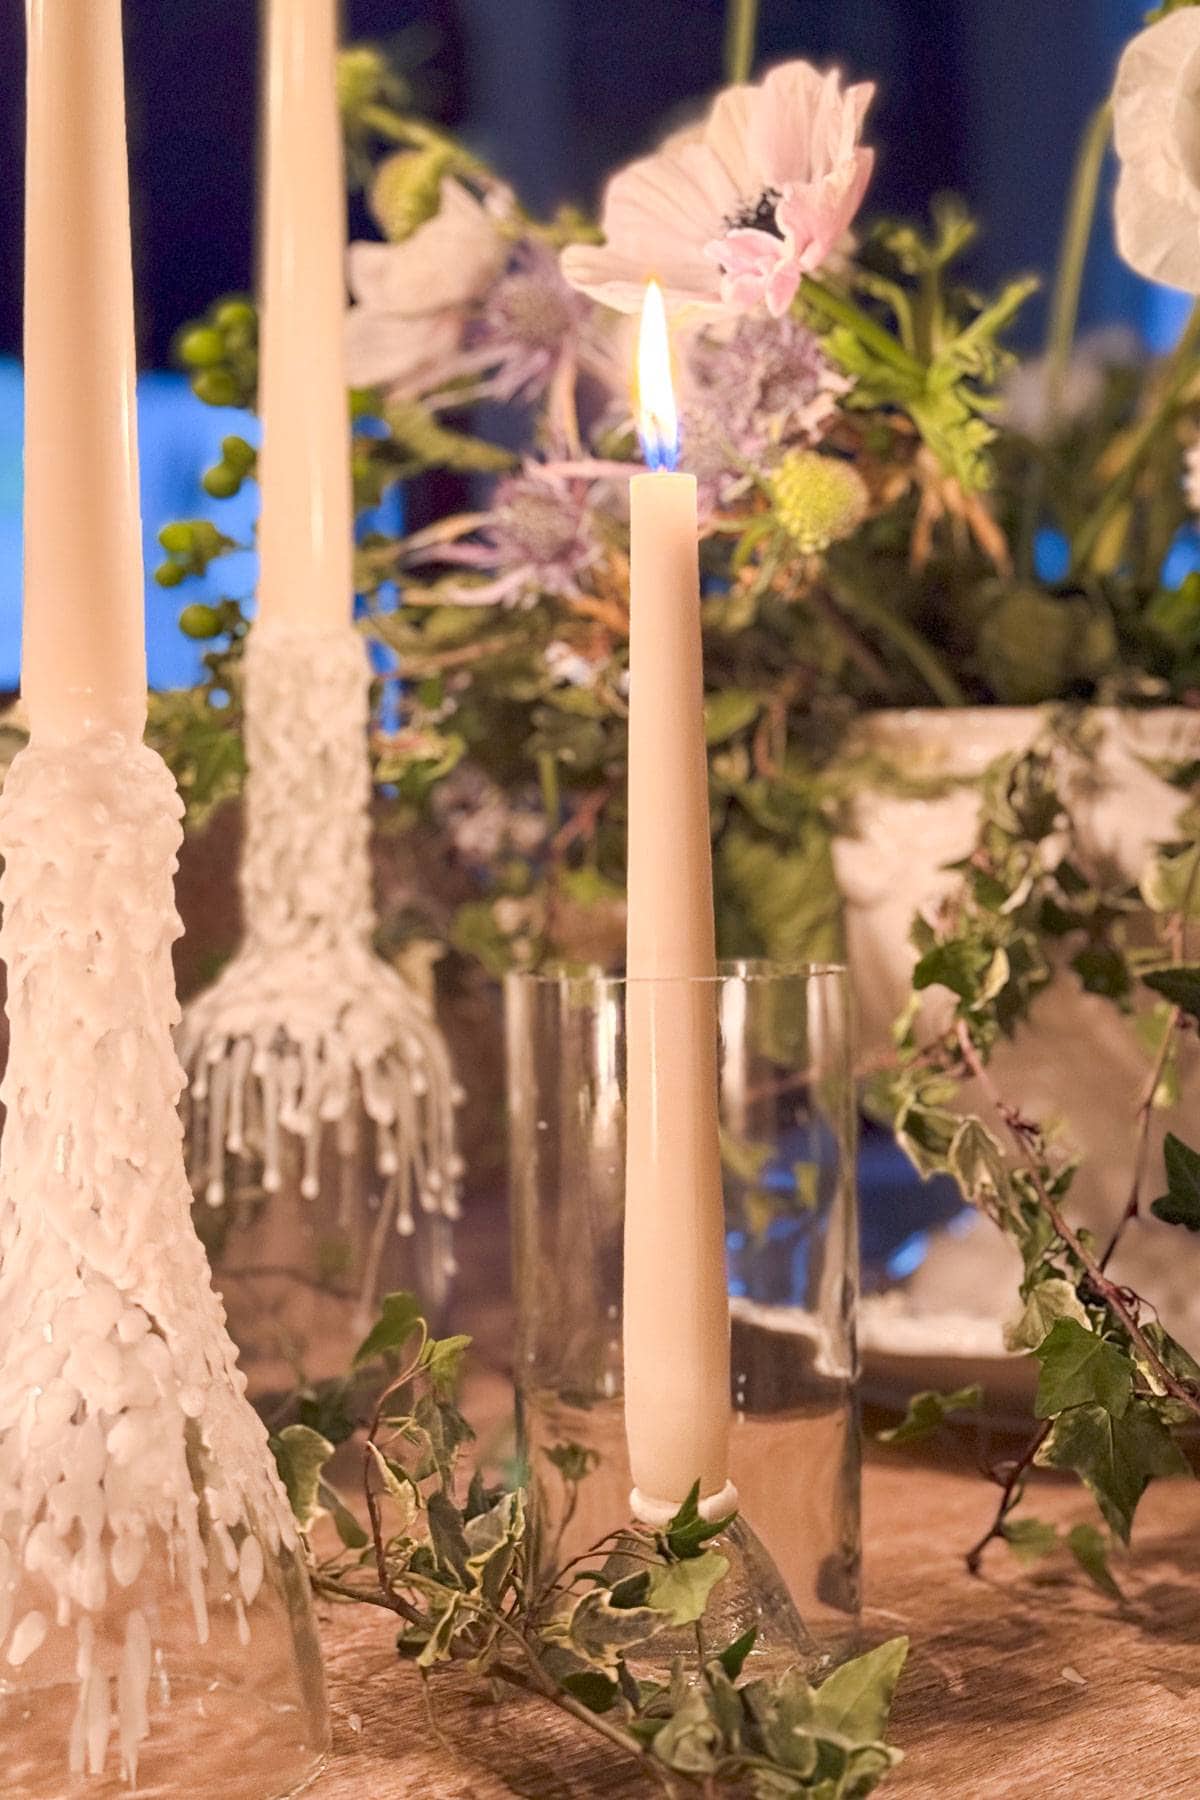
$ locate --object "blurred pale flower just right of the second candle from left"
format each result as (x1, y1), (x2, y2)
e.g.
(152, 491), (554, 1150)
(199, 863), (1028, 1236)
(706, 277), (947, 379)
(345, 178), (509, 394)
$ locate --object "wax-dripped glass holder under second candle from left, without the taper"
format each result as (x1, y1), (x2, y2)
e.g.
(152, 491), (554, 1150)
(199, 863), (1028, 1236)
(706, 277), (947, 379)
(180, 621), (462, 1391)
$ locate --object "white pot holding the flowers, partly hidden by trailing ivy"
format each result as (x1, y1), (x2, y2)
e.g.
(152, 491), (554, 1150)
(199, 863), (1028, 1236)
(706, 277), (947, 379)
(833, 707), (1200, 1354)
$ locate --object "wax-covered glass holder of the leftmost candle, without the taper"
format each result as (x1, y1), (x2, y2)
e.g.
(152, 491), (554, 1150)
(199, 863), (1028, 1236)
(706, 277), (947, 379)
(0, 734), (327, 1800)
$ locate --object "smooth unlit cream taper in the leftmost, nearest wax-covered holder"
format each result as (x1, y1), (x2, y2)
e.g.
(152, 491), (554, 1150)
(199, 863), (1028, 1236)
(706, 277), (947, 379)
(22, 0), (146, 742)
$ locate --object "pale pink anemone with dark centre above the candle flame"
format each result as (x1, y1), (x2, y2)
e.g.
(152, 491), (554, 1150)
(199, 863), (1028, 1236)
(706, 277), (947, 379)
(563, 63), (874, 317)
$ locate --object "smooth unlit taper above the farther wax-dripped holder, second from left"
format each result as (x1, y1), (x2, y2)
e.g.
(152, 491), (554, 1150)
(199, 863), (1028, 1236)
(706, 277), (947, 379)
(259, 0), (354, 628)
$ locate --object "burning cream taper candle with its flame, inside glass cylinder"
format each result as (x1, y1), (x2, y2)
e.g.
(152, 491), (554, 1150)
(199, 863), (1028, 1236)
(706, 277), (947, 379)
(624, 284), (736, 1525)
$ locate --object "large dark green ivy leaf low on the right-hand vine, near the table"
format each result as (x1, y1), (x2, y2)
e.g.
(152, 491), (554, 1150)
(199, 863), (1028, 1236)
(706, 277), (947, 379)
(1036, 1400), (1189, 1544)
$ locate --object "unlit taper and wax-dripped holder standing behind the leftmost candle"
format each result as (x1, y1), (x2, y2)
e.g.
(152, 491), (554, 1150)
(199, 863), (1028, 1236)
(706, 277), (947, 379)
(180, 0), (462, 1390)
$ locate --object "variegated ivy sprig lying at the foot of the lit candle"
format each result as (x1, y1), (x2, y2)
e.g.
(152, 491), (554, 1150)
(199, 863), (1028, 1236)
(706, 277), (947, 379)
(272, 1294), (907, 1800)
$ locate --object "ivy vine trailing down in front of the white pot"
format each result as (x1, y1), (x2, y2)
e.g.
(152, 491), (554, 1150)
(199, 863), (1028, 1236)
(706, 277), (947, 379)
(878, 720), (1200, 1593)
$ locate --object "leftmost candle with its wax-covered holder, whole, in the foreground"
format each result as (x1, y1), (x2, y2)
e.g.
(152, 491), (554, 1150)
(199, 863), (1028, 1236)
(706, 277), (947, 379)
(0, 0), (327, 1800)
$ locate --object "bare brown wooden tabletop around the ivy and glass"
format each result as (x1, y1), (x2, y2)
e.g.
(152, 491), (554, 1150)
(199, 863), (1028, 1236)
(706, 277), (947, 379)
(300, 1202), (1200, 1800)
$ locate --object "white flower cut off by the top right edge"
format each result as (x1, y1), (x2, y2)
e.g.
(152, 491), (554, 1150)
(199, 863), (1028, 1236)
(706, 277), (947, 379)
(1114, 7), (1200, 293)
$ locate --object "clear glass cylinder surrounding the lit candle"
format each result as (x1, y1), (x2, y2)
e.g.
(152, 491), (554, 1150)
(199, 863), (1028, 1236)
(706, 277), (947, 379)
(506, 963), (860, 1661)
